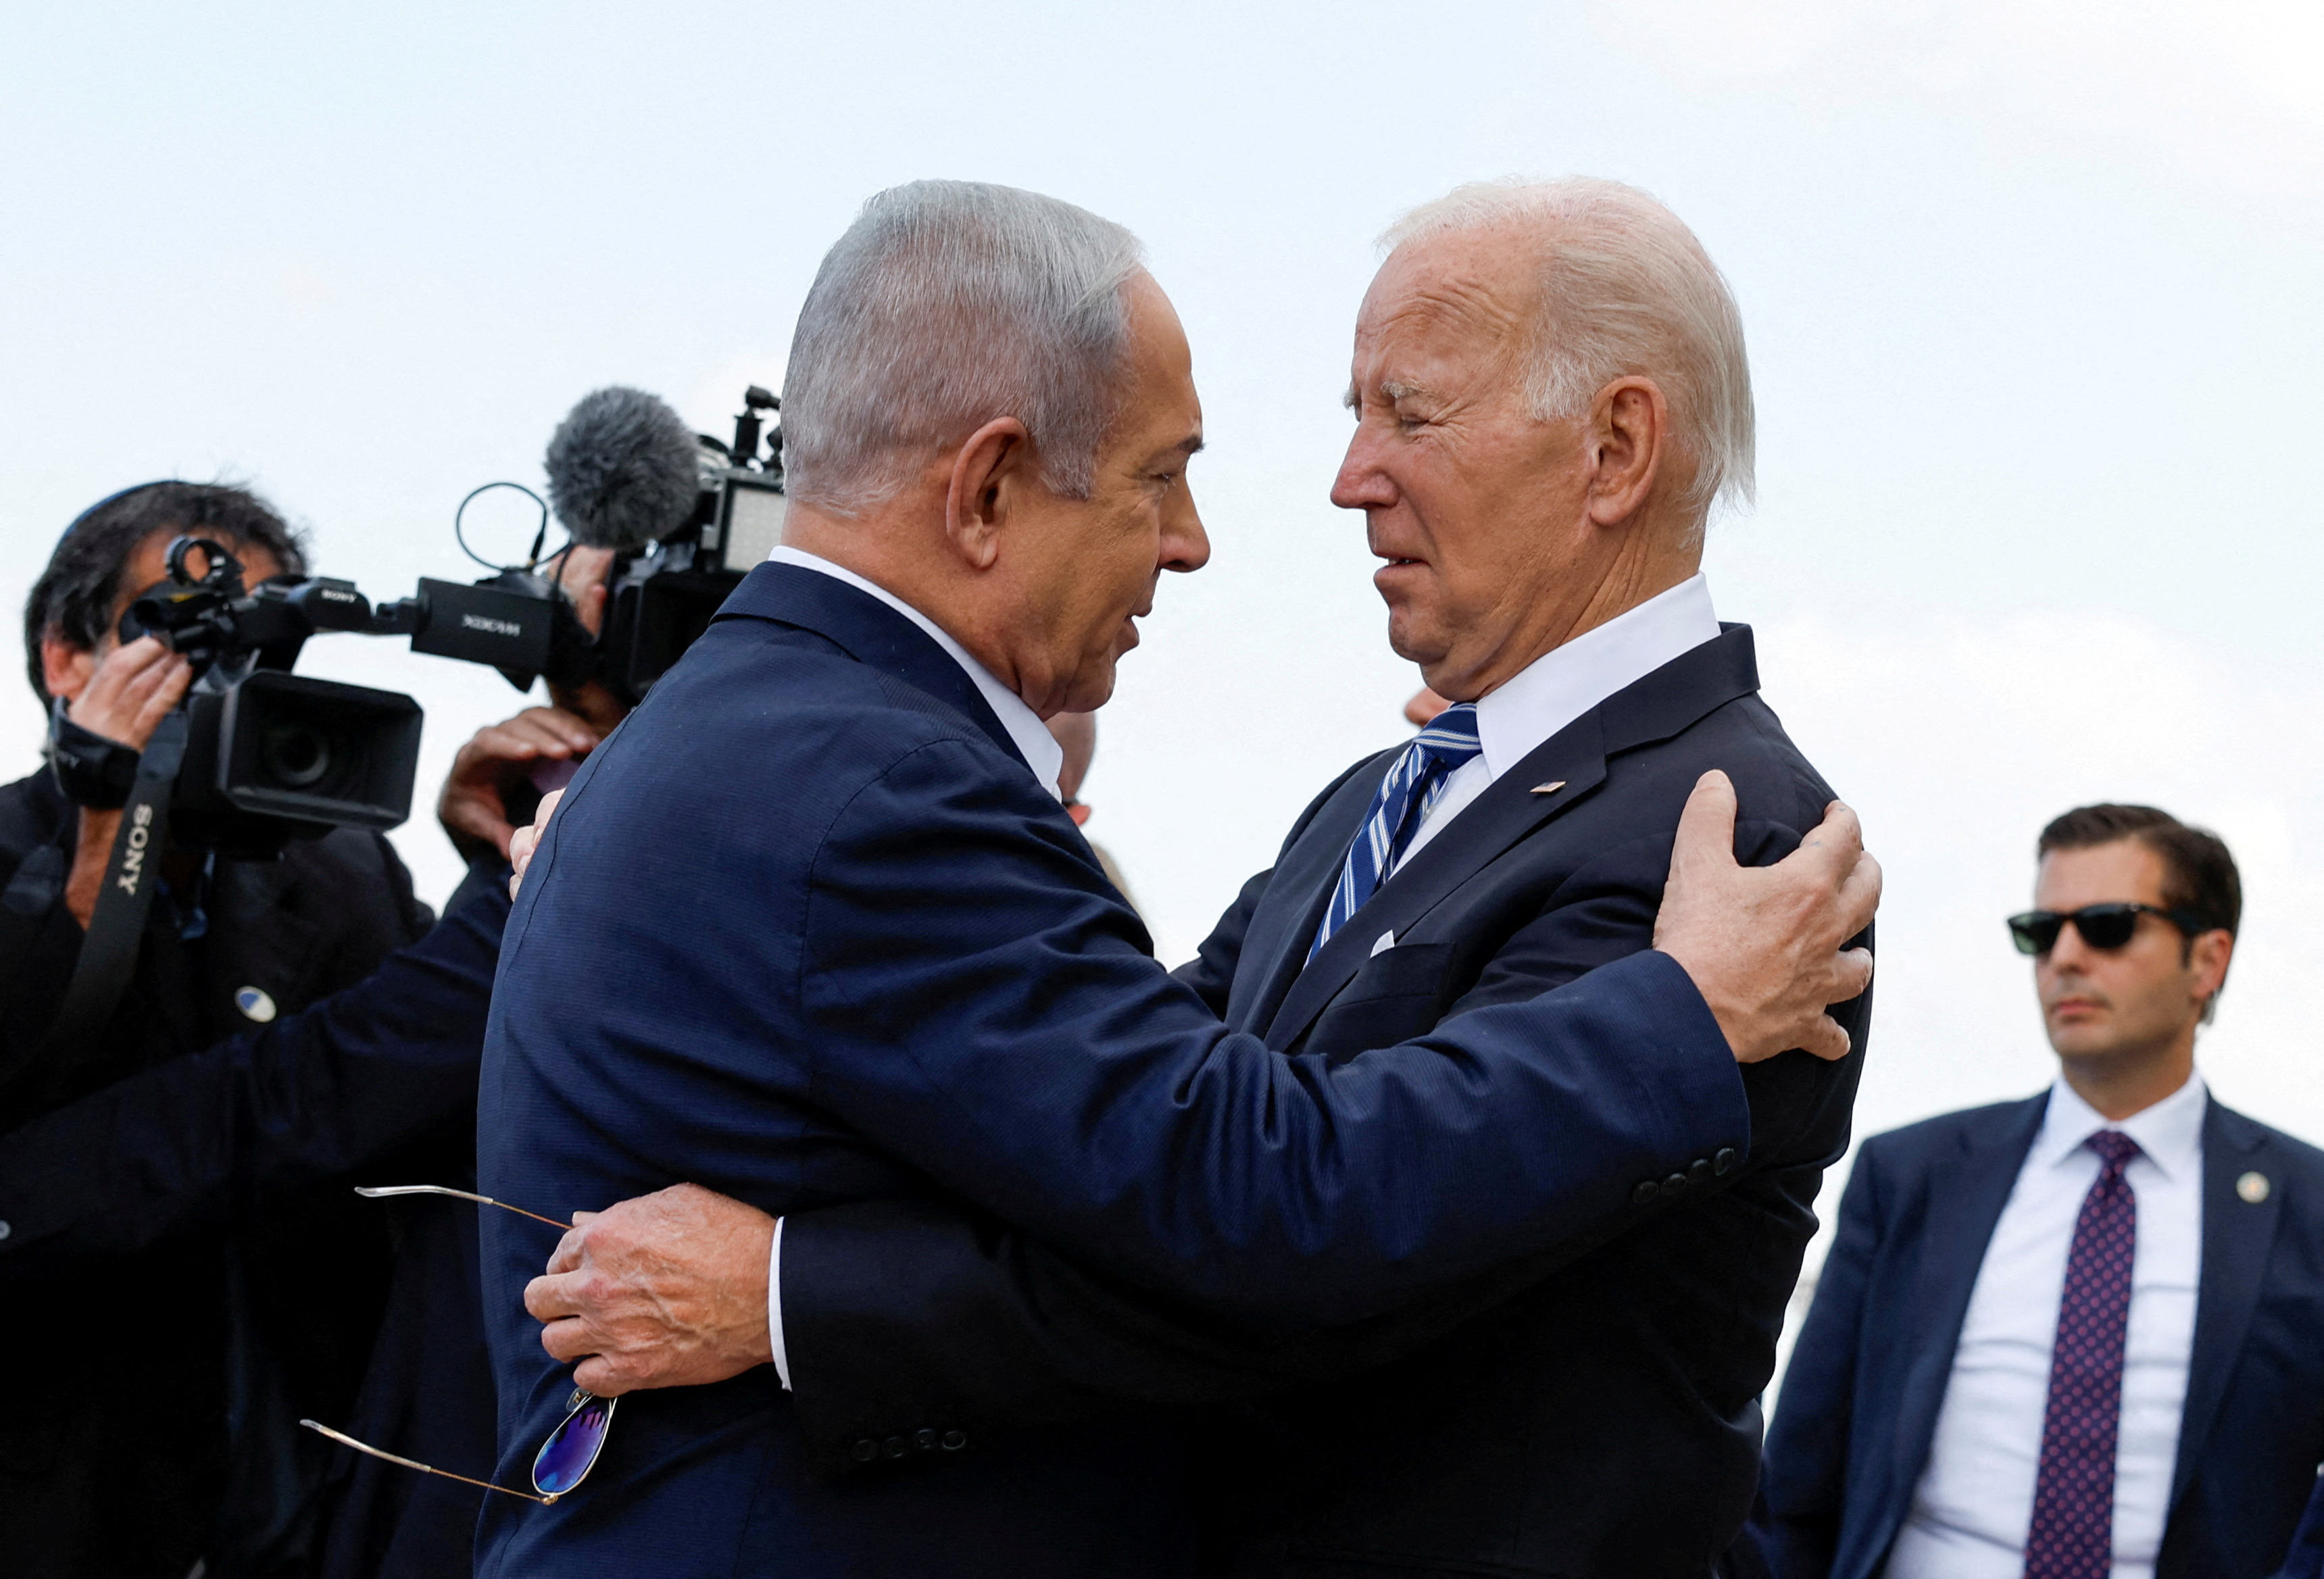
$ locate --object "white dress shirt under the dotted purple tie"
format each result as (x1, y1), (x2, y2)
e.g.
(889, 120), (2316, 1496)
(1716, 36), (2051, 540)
(1887, 1075), (2210, 1579)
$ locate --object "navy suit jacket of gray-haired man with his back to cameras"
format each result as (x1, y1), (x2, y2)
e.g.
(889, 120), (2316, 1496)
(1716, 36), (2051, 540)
(462, 564), (1750, 1579)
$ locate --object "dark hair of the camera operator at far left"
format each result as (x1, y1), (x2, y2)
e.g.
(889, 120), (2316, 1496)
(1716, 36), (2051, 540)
(23, 483), (307, 701)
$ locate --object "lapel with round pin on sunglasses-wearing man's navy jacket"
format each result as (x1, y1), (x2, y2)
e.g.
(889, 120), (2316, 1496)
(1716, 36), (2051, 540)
(2171, 1101), (2282, 1507)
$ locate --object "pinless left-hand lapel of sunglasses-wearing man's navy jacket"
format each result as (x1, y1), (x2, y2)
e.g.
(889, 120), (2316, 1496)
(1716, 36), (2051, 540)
(1894, 1091), (2050, 1519)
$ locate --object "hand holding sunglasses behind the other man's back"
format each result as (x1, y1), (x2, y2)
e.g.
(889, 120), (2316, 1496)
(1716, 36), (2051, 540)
(525, 1184), (774, 1398)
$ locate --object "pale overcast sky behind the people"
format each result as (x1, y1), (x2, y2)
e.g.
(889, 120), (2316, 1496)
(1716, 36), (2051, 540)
(0, 0), (2324, 1216)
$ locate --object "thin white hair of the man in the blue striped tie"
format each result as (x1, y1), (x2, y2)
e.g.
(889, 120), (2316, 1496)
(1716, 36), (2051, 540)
(1381, 176), (1754, 516)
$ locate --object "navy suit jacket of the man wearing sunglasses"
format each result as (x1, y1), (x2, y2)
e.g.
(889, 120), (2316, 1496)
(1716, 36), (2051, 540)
(1759, 1096), (2324, 1579)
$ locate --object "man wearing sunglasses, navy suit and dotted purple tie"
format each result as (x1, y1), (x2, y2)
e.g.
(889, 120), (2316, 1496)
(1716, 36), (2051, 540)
(1757, 806), (2324, 1579)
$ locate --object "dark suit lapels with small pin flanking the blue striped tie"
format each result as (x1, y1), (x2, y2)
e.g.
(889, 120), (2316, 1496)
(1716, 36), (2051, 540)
(1266, 624), (1759, 1047)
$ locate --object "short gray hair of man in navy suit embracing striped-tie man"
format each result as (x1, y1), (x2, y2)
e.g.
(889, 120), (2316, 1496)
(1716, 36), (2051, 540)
(783, 181), (1141, 511)
